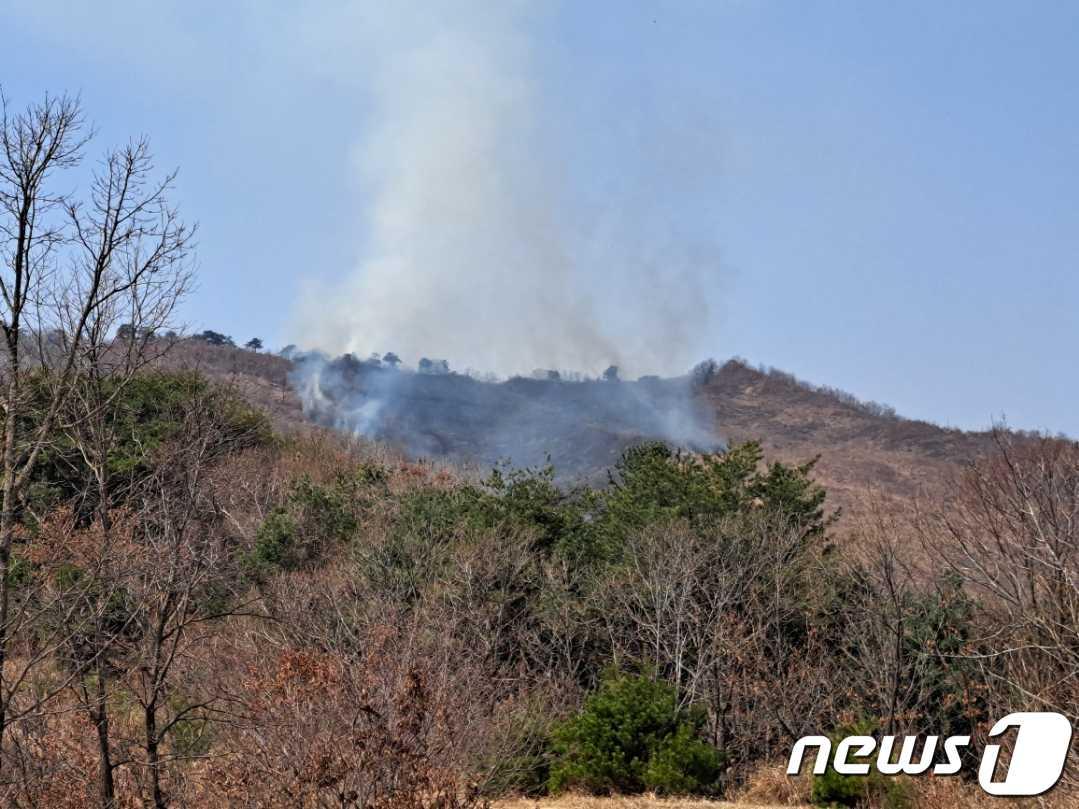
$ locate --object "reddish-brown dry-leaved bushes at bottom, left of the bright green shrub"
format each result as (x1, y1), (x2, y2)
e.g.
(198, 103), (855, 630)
(204, 650), (481, 809)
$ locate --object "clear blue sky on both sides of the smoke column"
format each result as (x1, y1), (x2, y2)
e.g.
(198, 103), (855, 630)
(0, 0), (1079, 435)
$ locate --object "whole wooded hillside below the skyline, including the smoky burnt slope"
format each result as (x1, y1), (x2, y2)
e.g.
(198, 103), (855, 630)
(12, 341), (1079, 809)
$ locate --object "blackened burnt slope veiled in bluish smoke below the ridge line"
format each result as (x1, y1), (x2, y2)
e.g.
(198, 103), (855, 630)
(291, 355), (723, 480)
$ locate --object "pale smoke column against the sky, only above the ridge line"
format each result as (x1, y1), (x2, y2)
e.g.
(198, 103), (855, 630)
(295, 3), (718, 375)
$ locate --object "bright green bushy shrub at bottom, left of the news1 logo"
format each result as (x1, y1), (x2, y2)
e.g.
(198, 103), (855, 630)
(548, 675), (721, 794)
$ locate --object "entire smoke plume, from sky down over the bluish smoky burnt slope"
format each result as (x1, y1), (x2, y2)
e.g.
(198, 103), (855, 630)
(293, 2), (720, 479)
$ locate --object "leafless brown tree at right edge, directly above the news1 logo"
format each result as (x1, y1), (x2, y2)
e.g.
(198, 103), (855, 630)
(921, 429), (1079, 719)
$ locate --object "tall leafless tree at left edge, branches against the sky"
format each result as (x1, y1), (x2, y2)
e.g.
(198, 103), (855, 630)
(0, 91), (193, 799)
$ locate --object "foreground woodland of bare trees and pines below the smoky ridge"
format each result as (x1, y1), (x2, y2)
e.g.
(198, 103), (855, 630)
(0, 97), (1079, 809)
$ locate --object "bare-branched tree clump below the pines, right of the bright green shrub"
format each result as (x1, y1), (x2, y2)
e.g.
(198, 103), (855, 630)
(597, 513), (833, 780)
